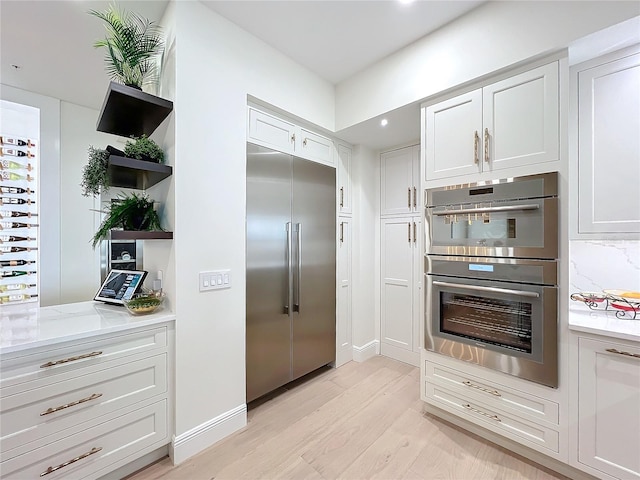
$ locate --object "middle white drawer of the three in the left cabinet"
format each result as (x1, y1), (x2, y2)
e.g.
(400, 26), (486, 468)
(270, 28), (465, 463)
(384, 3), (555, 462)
(0, 354), (167, 461)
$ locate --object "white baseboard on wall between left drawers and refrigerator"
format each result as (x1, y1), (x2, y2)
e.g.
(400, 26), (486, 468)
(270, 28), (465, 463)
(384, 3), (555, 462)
(169, 403), (247, 465)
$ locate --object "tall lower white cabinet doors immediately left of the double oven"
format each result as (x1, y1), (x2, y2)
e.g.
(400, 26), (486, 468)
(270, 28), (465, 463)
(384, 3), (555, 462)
(380, 216), (422, 366)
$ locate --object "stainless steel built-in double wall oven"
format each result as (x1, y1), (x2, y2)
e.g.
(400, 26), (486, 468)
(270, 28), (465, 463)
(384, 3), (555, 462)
(425, 172), (558, 387)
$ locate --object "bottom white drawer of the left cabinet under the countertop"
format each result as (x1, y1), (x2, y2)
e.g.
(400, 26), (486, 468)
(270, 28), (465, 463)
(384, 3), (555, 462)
(0, 400), (169, 480)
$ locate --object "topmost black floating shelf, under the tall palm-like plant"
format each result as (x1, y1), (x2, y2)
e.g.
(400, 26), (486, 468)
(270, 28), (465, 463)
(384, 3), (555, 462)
(96, 82), (173, 137)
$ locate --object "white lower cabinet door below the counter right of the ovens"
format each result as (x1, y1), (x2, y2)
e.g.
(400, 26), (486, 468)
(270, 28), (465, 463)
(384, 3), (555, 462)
(578, 337), (640, 479)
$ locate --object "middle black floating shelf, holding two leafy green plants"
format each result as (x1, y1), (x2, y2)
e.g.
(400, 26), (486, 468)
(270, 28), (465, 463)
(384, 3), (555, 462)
(107, 155), (173, 190)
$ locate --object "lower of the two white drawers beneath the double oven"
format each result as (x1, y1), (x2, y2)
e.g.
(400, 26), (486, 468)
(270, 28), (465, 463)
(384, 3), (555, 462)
(425, 382), (560, 453)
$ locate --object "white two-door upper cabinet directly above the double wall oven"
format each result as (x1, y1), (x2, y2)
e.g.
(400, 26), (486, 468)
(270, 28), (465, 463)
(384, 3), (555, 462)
(423, 62), (560, 181)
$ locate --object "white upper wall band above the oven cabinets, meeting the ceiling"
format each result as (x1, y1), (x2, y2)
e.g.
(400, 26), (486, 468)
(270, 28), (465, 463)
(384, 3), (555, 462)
(336, 1), (640, 130)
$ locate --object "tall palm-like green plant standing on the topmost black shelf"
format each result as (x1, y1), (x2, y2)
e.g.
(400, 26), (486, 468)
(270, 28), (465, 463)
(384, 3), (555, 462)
(88, 4), (164, 89)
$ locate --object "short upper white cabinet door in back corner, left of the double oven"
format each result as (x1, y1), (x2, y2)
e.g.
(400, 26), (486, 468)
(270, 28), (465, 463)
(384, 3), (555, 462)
(380, 147), (414, 215)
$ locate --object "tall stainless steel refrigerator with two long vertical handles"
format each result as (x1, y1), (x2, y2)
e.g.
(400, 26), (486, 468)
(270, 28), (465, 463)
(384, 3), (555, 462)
(246, 144), (336, 402)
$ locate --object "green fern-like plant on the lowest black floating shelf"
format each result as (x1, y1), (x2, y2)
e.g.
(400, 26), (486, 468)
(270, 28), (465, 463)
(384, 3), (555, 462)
(93, 193), (163, 248)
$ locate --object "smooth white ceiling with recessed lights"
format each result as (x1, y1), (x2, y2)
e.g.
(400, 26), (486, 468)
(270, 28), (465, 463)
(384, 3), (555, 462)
(0, 0), (484, 148)
